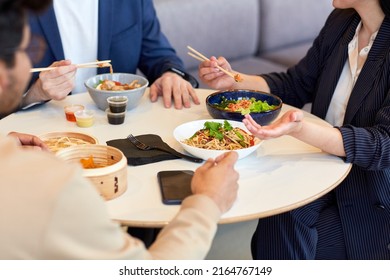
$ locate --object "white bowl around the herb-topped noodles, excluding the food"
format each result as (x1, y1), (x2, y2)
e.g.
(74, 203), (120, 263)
(173, 119), (262, 160)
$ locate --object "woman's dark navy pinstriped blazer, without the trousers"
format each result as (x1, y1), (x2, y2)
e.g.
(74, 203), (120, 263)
(263, 9), (390, 259)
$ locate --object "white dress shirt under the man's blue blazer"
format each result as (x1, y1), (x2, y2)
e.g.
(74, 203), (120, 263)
(54, 0), (99, 93)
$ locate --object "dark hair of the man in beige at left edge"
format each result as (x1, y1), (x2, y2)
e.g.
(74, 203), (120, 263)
(0, 0), (52, 67)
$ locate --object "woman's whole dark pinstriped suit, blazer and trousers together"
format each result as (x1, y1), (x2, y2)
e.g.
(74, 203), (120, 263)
(252, 9), (390, 259)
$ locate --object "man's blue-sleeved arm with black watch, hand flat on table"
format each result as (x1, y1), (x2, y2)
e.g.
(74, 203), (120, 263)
(138, 0), (200, 109)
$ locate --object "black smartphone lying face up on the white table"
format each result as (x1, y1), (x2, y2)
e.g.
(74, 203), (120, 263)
(157, 170), (194, 204)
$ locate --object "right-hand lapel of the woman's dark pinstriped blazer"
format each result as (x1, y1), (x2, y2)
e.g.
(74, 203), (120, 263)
(344, 17), (390, 123)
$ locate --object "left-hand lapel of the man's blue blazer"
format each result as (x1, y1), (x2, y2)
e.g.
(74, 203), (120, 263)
(38, 6), (65, 61)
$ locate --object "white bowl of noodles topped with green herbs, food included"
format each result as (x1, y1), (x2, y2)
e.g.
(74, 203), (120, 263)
(173, 119), (262, 160)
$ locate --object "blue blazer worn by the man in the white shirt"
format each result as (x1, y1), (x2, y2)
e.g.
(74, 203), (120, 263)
(29, 0), (196, 85)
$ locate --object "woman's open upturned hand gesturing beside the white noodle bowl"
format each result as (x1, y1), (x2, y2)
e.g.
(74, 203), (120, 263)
(242, 109), (303, 140)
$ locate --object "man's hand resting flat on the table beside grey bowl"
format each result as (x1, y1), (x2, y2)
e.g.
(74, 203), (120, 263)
(150, 72), (200, 109)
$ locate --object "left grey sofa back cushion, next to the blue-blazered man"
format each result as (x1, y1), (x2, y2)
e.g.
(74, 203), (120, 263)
(154, 0), (260, 69)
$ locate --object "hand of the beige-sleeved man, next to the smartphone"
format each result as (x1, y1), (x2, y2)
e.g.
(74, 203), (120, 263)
(191, 151), (239, 213)
